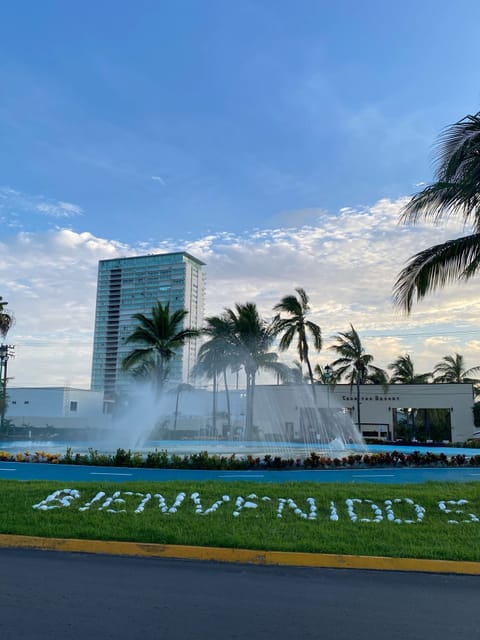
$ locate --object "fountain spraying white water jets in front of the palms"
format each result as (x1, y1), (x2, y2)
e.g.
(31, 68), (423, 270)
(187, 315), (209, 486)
(98, 384), (364, 458)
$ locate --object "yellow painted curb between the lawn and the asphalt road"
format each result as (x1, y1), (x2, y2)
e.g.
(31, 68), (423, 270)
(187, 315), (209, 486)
(0, 534), (480, 575)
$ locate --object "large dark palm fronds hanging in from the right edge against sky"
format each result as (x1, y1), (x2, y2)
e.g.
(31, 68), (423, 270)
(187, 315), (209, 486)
(394, 112), (480, 313)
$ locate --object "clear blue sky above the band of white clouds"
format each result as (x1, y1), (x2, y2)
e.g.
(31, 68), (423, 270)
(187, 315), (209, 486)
(0, 0), (480, 241)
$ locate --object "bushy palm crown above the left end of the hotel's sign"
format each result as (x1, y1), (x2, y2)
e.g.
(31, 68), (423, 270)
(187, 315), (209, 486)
(329, 324), (387, 385)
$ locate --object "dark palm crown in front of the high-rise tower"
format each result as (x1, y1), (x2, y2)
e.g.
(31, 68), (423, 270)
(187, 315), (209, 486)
(122, 300), (199, 393)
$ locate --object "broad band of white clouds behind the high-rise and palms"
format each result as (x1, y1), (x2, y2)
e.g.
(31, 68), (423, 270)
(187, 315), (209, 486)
(0, 195), (480, 386)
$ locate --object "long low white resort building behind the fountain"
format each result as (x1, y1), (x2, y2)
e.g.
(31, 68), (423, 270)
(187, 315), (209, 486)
(6, 384), (475, 442)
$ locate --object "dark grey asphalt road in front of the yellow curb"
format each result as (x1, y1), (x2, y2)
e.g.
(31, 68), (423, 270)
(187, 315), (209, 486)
(0, 549), (480, 640)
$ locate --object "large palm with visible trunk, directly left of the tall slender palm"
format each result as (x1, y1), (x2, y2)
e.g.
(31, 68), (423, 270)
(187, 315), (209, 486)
(225, 302), (288, 440)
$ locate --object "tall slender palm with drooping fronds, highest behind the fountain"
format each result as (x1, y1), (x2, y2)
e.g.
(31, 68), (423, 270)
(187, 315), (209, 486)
(273, 287), (322, 398)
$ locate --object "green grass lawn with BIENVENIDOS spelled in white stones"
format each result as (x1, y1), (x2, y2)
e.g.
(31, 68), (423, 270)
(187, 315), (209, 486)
(0, 480), (480, 561)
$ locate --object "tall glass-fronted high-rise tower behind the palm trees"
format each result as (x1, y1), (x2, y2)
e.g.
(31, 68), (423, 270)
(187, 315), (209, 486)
(91, 252), (205, 398)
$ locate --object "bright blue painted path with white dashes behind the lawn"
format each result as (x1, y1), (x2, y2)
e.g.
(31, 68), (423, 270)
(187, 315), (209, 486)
(0, 462), (480, 484)
